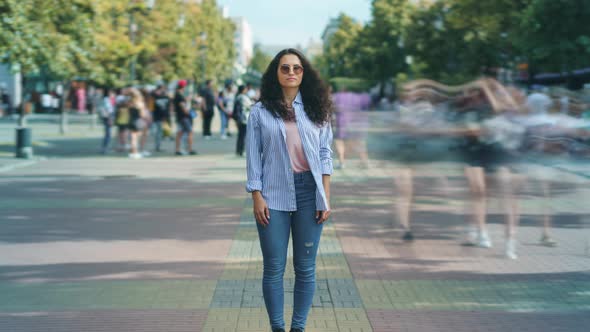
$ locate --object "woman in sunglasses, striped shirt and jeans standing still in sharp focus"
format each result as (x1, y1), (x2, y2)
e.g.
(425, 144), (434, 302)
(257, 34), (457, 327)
(246, 49), (333, 332)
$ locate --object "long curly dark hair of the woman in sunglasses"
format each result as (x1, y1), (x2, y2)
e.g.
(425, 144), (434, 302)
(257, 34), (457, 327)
(260, 48), (333, 126)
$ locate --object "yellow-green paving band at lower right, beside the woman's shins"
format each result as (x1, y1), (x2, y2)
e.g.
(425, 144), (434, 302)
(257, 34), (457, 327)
(356, 280), (590, 312)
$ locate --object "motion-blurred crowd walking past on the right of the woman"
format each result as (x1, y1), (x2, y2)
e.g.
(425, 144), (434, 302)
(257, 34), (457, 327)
(333, 78), (590, 259)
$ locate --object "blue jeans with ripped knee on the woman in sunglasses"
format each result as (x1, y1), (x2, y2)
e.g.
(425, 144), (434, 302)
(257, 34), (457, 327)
(257, 172), (323, 329)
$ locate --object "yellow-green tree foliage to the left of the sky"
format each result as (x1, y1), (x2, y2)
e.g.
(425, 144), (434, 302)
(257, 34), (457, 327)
(0, 0), (235, 86)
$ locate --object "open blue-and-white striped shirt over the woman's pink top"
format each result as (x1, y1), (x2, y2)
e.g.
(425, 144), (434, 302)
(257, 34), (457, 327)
(246, 93), (333, 211)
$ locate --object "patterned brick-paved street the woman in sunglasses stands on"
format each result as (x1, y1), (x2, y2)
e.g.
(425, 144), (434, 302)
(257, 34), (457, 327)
(0, 113), (590, 332)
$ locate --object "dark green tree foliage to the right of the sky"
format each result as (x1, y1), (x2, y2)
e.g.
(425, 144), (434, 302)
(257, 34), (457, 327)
(317, 0), (590, 88)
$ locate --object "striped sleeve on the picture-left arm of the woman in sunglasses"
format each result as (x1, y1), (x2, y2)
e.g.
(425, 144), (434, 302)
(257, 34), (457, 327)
(246, 104), (262, 193)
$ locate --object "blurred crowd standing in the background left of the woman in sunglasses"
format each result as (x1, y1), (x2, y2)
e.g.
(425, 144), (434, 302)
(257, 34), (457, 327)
(92, 80), (259, 159)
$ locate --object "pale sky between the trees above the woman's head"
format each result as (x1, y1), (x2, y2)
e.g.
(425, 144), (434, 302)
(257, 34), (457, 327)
(217, 0), (371, 47)
